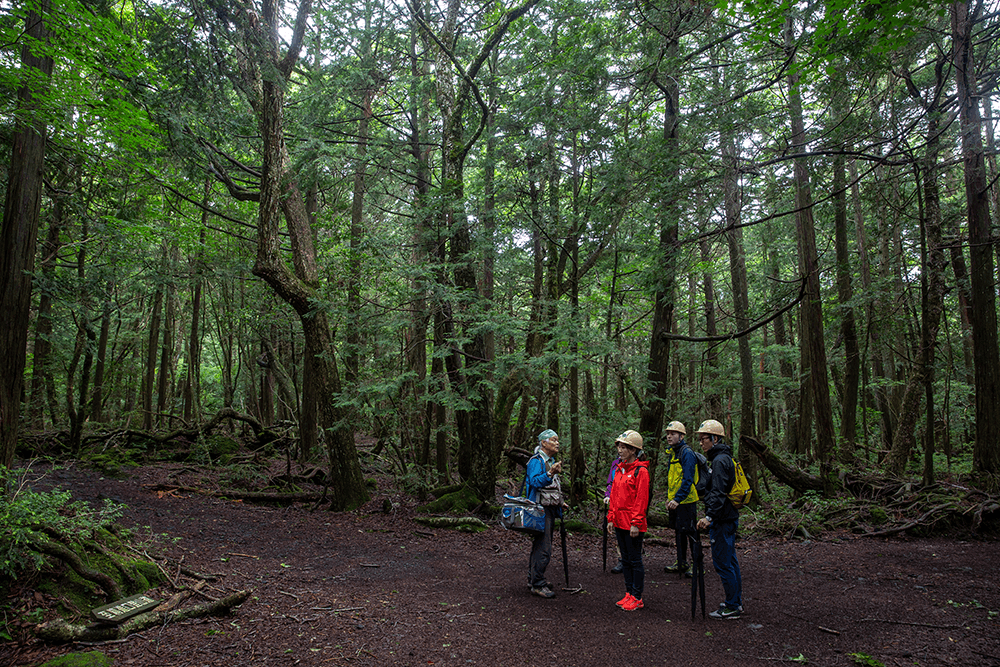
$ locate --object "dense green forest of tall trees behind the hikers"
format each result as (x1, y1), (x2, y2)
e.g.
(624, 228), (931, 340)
(0, 0), (1000, 500)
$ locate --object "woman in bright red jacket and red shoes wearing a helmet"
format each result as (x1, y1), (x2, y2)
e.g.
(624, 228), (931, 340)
(608, 430), (649, 611)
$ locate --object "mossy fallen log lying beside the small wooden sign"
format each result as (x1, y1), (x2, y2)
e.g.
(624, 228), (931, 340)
(35, 590), (253, 642)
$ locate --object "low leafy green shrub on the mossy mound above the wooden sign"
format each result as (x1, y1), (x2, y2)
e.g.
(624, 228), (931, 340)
(0, 469), (124, 578)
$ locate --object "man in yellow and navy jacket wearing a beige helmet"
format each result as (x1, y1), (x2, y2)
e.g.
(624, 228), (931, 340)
(663, 421), (700, 577)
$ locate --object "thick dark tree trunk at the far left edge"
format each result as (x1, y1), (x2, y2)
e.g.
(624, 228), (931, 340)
(0, 0), (53, 468)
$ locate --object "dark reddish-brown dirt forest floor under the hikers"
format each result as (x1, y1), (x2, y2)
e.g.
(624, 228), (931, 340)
(0, 464), (1000, 667)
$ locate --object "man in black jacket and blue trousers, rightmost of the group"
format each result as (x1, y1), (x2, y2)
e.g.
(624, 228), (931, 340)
(695, 419), (743, 619)
